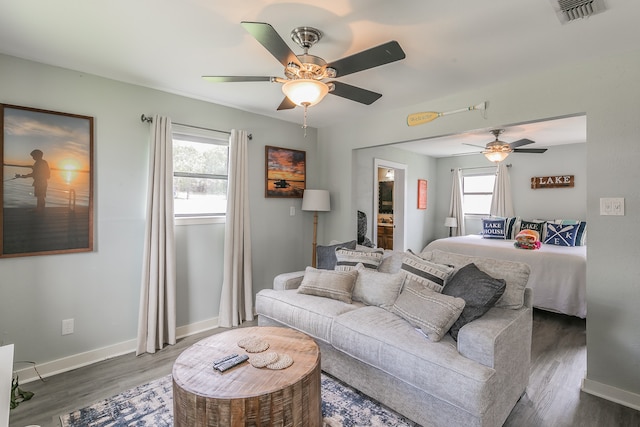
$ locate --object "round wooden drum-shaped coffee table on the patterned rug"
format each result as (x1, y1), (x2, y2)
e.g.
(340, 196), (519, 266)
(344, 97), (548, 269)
(173, 326), (322, 427)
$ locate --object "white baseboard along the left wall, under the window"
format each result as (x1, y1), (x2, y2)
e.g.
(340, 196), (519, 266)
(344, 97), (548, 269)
(15, 317), (218, 384)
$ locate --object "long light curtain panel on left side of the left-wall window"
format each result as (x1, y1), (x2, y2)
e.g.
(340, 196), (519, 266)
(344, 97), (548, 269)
(136, 115), (176, 354)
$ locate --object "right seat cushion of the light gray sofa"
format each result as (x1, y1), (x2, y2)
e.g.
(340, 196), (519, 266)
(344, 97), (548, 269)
(331, 306), (497, 413)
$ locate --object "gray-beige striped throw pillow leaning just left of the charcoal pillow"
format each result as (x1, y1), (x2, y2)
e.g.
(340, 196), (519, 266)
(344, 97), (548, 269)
(391, 281), (465, 342)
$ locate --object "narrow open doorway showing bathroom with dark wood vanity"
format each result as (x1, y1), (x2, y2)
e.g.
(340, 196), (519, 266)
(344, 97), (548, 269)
(372, 159), (407, 251)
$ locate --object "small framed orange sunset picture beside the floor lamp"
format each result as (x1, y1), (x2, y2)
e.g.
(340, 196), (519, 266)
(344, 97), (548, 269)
(264, 146), (307, 198)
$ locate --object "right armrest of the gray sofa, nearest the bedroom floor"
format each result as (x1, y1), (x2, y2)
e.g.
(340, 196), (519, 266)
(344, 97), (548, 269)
(458, 290), (533, 369)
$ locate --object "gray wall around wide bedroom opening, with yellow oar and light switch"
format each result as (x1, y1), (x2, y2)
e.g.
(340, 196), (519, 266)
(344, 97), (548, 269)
(318, 51), (640, 407)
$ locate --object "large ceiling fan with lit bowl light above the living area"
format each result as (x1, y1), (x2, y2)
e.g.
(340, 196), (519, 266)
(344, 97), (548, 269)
(203, 21), (405, 127)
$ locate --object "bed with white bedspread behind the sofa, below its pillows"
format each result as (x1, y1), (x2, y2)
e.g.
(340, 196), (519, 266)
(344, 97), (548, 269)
(424, 235), (587, 318)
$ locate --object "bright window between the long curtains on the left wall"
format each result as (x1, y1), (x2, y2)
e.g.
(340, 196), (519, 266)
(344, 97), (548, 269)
(173, 125), (229, 217)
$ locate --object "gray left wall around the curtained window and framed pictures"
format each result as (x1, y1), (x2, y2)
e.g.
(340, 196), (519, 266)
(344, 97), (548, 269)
(0, 55), (318, 368)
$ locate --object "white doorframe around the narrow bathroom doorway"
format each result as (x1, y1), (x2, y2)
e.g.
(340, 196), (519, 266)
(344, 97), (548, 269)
(371, 158), (408, 252)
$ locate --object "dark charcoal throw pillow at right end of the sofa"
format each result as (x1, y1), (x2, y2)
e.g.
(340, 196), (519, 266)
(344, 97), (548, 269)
(442, 263), (507, 341)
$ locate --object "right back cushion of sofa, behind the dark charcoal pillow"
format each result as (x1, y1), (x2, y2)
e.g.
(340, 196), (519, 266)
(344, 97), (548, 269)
(421, 249), (531, 310)
